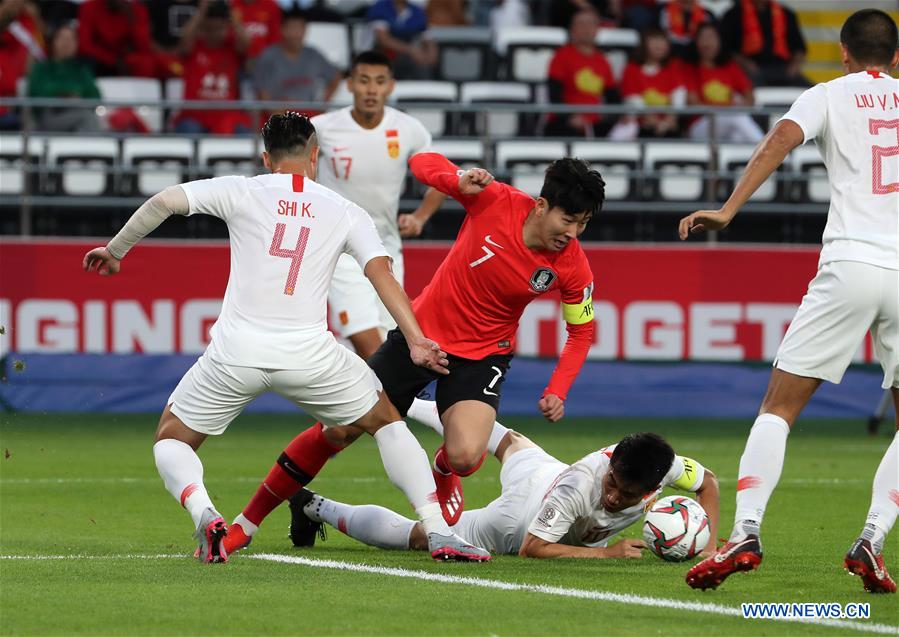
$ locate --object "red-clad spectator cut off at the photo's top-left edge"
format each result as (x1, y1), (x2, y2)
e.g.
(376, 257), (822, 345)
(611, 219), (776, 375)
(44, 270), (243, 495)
(0, 0), (45, 130)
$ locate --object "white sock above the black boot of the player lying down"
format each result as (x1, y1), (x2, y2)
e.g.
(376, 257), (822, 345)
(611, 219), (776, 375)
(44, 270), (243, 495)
(303, 495), (415, 550)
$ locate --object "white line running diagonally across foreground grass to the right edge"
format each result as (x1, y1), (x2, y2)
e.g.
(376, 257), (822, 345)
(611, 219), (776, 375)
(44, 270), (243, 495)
(247, 553), (899, 635)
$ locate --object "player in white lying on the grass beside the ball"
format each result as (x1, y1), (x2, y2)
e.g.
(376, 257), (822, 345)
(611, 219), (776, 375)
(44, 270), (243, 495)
(291, 401), (718, 558)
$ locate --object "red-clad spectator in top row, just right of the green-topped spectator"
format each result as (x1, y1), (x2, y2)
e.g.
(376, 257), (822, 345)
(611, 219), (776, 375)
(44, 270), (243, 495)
(78, 0), (180, 78)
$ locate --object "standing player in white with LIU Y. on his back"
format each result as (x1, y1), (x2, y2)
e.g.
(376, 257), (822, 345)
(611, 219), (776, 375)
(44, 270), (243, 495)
(680, 9), (899, 593)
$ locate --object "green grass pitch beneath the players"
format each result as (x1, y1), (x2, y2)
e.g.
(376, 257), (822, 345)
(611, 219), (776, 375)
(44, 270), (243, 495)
(0, 414), (899, 637)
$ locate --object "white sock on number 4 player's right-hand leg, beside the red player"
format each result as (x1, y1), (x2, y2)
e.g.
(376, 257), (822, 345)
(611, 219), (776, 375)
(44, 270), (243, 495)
(374, 420), (450, 535)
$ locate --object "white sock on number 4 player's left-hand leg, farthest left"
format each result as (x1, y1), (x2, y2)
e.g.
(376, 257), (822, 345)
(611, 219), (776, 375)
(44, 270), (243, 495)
(153, 438), (215, 527)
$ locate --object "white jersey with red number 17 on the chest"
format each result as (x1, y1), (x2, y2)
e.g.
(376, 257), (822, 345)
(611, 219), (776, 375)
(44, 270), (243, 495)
(312, 106), (431, 255)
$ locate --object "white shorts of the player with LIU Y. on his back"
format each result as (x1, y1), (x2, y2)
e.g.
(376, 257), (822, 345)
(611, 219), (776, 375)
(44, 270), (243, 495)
(774, 261), (899, 388)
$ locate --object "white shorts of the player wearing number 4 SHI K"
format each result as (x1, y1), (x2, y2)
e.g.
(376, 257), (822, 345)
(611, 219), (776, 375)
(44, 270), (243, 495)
(168, 341), (381, 436)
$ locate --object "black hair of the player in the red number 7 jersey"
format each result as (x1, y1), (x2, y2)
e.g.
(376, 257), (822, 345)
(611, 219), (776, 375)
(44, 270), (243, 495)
(540, 157), (606, 218)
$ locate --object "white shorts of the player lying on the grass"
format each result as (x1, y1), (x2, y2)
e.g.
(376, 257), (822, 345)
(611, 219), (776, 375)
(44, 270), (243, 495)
(453, 447), (568, 555)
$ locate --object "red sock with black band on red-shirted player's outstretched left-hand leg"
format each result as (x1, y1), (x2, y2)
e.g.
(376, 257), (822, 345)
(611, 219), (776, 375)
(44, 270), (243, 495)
(243, 422), (341, 526)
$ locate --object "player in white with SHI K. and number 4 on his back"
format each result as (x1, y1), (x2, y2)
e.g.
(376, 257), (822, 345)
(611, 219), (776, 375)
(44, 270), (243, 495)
(83, 112), (490, 562)
